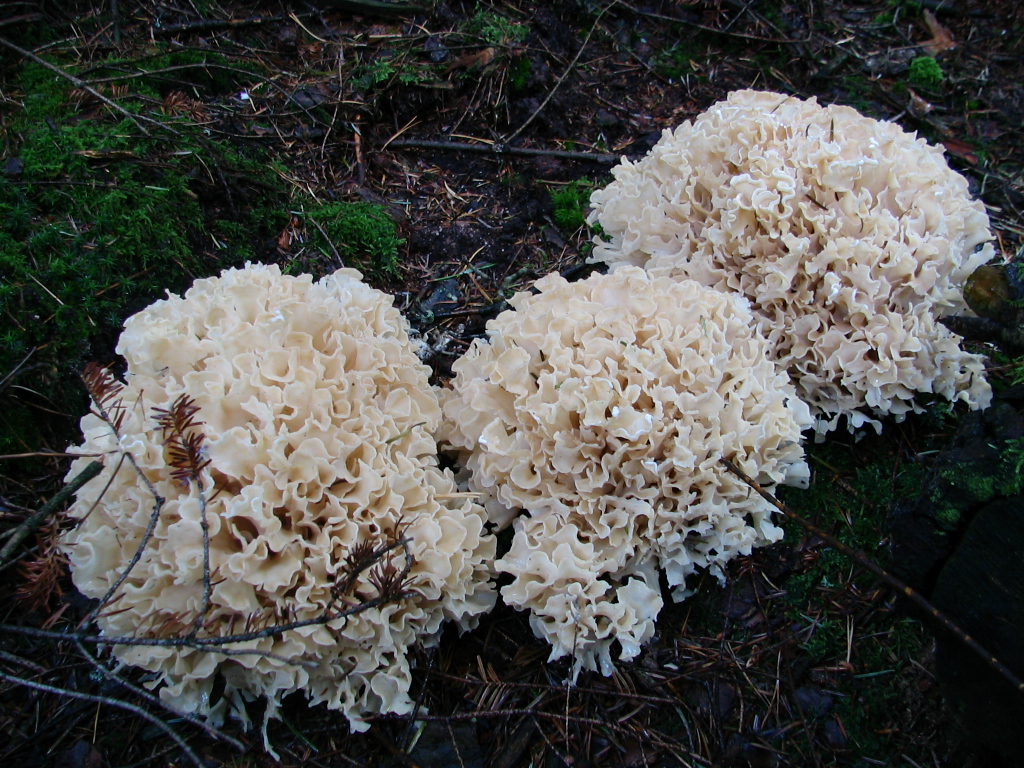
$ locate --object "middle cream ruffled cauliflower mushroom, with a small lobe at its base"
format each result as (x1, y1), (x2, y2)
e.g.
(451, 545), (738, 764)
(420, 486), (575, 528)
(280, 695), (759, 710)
(441, 267), (811, 675)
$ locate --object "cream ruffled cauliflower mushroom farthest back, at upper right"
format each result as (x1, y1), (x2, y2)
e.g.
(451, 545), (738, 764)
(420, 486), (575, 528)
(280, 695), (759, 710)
(589, 90), (993, 432)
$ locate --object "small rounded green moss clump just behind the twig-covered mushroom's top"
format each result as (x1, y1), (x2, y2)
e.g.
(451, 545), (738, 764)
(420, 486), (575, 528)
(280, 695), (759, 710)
(306, 203), (404, 278)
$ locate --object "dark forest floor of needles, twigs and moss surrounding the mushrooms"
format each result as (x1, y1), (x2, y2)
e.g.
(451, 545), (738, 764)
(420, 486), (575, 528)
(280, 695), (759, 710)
(0, 0), (1024, 768)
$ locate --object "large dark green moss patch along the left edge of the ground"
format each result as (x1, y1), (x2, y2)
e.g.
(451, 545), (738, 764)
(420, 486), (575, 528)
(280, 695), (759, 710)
(0, 51), (287, 452)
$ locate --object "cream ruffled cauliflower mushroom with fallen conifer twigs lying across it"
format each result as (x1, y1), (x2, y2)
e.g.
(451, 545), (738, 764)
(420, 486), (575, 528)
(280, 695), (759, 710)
(63, 265), (497, 730)
